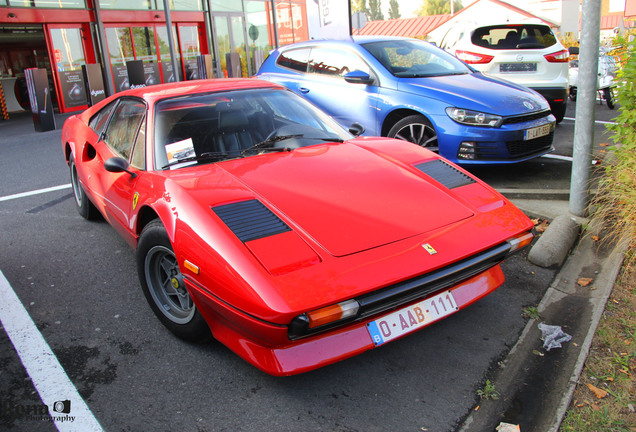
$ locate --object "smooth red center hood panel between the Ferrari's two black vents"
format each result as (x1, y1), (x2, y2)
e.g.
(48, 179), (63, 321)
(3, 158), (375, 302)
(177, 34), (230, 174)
(217, 143), (473, 256)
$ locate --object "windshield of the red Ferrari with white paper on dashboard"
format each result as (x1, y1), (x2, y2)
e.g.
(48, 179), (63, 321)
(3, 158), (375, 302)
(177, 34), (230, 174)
(154, 89), (353, 169)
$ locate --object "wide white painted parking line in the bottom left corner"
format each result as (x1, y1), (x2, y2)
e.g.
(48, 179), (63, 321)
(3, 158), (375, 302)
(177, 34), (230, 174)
(0, 271), (103, 432)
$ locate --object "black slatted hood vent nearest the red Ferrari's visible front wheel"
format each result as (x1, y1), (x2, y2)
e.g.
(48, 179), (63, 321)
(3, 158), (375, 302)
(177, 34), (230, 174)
(212, 200), (291, 243)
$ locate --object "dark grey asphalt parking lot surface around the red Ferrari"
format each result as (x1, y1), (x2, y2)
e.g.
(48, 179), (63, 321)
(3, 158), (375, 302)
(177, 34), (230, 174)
(0, 99), (615, 431)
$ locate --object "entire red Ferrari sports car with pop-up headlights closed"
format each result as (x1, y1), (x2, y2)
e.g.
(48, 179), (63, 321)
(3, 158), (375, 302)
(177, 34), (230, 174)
(62, 79), (533, 375)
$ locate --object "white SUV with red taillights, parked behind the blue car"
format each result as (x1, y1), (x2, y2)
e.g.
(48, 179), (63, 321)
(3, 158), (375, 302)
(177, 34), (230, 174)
(440, 23), (569, 122)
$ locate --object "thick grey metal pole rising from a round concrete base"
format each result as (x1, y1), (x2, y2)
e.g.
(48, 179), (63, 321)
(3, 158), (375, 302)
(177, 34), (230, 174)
(570, 0), (601, 217)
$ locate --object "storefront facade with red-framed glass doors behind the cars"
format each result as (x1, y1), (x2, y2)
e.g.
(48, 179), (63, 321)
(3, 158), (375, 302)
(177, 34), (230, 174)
(0, 0), (313, 113)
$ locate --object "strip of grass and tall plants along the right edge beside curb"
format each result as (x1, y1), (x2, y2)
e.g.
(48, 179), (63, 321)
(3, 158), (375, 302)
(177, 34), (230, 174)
(560, 31), (636, 432)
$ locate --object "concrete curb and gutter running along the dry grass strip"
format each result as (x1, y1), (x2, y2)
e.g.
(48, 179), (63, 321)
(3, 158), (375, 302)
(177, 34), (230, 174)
(458, 226), (624, 432)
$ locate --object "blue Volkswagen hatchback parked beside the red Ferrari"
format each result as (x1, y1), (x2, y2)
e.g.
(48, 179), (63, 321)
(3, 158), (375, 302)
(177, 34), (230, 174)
(257, 36), (555, 164)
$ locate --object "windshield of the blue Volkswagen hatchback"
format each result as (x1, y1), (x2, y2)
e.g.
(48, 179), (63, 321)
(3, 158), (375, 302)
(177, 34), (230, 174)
(362, 40), (472, 78)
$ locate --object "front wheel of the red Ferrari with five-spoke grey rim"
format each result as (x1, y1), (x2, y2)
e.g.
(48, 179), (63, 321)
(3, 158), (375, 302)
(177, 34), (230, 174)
(137, 219), (211, 342)
